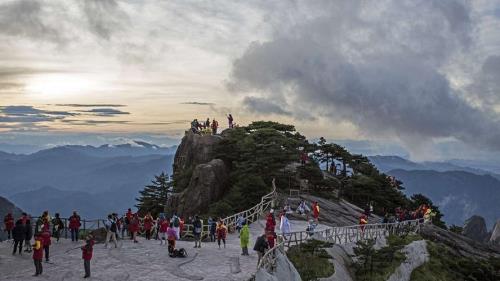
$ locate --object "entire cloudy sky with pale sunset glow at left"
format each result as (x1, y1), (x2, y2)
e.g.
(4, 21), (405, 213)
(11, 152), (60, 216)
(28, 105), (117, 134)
(0, 0), (500, 160)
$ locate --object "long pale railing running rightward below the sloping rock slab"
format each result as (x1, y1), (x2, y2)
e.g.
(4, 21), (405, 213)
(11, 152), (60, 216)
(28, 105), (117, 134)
(257, 219), (424, 272)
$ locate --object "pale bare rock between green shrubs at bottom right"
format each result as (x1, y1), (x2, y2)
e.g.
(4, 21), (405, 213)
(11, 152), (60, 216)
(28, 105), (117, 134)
(388, 240), (429, 281)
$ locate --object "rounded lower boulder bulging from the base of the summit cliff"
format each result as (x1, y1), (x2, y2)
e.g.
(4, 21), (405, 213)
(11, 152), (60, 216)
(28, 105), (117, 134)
(166, 159), (229, 217)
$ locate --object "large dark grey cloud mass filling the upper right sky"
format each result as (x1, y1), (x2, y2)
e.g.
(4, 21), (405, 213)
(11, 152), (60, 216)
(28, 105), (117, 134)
(228, 1), (500, 149)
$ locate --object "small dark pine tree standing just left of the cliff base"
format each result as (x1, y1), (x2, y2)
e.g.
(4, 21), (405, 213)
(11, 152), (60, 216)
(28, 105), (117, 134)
(135, 173), (172, 217)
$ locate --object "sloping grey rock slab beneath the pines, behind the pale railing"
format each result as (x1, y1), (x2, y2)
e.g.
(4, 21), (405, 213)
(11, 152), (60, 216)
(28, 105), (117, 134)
(280, 194), (381, 226)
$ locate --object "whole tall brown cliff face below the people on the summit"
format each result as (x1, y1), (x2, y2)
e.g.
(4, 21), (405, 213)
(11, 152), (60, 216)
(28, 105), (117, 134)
(165, 131), (230, 217)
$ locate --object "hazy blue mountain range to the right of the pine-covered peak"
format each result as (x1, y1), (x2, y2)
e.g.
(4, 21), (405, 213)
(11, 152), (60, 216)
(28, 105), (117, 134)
(369, 156), (500, 228)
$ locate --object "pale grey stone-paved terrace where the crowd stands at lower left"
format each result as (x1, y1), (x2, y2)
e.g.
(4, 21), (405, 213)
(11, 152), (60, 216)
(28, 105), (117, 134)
(0, 221), (326, 281)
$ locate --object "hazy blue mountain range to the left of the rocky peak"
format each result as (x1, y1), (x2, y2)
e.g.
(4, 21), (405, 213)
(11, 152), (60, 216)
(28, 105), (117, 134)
(0, 141), (176, 218)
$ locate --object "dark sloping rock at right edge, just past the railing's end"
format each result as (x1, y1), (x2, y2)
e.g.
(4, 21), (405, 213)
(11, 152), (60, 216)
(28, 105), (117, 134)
(420, 221), (500, 258)
